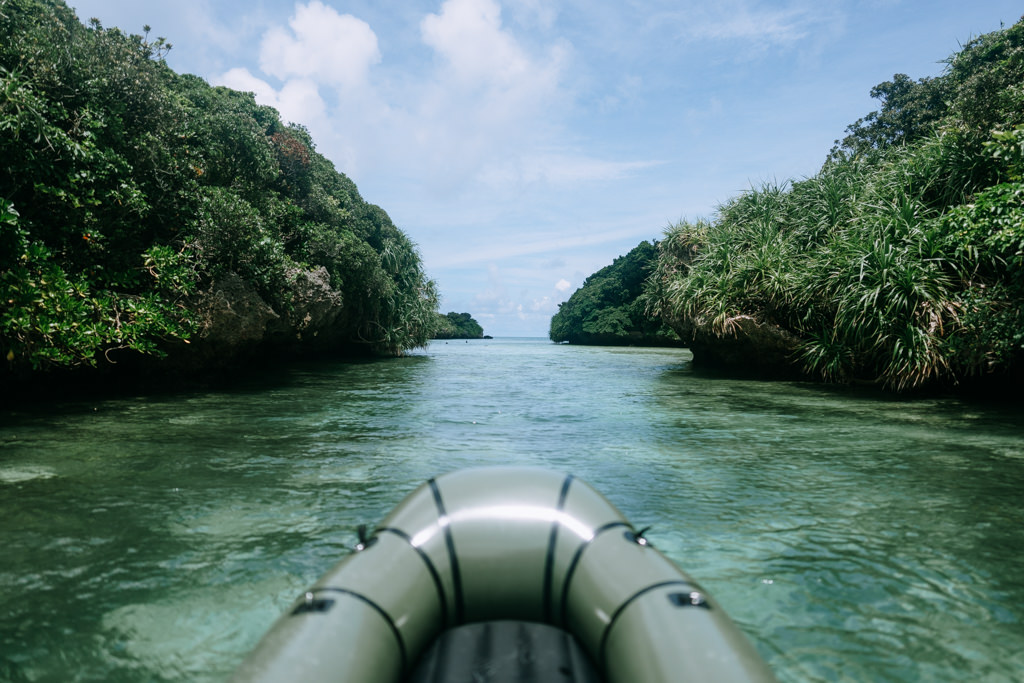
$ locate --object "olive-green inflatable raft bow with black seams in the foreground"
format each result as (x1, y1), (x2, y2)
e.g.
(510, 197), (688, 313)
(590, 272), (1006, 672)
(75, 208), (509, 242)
(234, 467), (774, 683)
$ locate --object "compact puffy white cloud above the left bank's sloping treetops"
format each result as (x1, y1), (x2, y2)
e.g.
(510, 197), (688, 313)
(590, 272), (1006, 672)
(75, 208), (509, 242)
(260, 0), (381, 88)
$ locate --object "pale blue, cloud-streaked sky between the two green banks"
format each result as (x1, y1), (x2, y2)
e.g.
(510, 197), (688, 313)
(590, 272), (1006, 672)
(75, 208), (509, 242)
(69, 0), (1024, 337)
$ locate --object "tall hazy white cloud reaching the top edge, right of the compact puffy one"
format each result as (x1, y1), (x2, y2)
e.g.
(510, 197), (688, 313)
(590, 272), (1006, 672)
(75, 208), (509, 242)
(404, 0), (570, 196)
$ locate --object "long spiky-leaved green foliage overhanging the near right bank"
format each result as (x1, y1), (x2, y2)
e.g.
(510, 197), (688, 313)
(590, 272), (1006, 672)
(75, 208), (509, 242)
(650, 15), (1024, 388)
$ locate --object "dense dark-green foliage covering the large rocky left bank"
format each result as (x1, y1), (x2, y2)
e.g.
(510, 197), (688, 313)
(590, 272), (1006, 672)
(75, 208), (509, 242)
(0, 0), (436, 372)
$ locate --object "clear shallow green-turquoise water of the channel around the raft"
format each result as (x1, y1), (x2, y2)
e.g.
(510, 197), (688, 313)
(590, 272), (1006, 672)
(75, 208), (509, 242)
(0, 340), (1024, 682)
